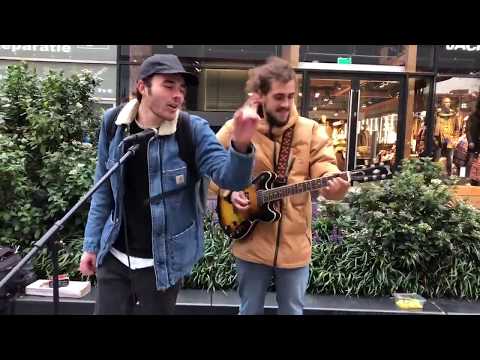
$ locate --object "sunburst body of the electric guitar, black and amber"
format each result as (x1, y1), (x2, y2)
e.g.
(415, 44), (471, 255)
(217, 171), (281, 240)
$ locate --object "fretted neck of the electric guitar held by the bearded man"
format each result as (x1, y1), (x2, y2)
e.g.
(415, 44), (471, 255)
(259, 171), (350, 204)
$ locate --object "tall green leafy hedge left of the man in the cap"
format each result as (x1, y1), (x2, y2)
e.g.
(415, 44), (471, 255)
(0, 63), (101, 278)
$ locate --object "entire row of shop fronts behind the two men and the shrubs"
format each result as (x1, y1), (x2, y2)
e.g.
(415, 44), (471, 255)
(0, 45), (480, 174)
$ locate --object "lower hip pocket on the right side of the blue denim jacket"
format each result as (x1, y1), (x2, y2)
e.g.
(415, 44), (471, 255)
(170, 221), (198, 271)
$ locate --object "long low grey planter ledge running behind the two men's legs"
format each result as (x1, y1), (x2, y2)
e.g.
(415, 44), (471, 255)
(8, 288), (480, 315)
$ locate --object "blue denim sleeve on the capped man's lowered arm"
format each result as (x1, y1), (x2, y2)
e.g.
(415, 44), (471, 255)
(83, 111), (113, 253)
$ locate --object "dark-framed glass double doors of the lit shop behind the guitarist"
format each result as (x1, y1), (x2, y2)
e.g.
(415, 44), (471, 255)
(303, 73), (405, 171)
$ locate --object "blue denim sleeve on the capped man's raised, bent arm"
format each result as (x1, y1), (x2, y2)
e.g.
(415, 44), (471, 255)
(193, 117), (255, 191)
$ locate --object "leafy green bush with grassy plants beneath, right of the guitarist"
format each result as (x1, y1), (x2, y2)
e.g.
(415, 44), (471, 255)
(309, 159), (480, 299)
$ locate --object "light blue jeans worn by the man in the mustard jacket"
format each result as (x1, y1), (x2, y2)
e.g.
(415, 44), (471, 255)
(236, 258), (308, 315)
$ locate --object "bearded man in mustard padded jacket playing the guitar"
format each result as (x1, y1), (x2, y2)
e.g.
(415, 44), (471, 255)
(213, 57), (349, 315)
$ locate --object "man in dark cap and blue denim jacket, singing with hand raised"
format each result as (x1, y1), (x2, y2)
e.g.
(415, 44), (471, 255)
(80, 55), (258, 314)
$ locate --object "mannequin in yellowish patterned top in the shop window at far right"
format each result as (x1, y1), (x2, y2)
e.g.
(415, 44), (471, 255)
(434, 97), (461, 176)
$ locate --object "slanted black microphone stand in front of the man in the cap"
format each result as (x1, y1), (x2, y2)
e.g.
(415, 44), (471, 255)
(0, 144), (140, 315)
